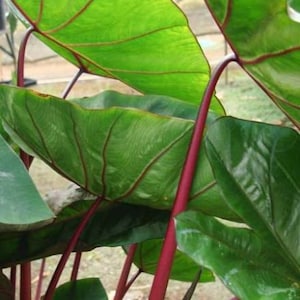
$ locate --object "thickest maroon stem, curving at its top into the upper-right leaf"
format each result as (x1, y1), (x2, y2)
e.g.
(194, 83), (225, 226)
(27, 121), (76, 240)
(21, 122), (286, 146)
(149, 54), (237, 300)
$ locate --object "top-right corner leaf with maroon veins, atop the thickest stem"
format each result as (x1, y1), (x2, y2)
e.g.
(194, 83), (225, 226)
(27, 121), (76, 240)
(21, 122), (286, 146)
(206, 0), (300, 127)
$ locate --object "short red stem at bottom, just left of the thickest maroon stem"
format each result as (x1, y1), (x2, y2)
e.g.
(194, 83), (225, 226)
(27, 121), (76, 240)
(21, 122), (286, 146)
(114, 244), (137, 300)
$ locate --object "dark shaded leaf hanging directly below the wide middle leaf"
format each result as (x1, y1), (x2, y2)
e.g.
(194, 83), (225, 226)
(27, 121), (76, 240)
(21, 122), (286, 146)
(0, 200), (170, 267)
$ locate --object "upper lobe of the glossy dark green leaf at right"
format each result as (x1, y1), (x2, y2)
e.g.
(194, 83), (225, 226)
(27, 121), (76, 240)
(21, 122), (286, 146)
(206, 118), (300, 273)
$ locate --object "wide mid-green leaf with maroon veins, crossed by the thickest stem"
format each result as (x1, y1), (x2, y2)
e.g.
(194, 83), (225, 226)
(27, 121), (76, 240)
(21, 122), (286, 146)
(0, 86), (235, 218)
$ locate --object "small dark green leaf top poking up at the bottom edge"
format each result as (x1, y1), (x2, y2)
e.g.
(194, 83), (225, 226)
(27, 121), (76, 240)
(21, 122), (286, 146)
(53, 278), (108, 300)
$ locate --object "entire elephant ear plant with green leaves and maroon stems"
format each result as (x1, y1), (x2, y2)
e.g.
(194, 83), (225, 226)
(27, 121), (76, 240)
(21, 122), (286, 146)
(0, 0), (300, 300)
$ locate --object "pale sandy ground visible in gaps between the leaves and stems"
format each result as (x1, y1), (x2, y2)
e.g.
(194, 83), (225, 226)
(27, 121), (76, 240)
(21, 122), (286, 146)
(0, 0), (288, 300)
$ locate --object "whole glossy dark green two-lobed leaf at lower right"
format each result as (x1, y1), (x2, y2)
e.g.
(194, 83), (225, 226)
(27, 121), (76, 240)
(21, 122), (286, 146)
(177, 118), (300, 300)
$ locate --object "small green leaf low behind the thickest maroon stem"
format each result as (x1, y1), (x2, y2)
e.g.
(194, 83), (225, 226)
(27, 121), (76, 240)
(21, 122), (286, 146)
(125, 239), (215, 282)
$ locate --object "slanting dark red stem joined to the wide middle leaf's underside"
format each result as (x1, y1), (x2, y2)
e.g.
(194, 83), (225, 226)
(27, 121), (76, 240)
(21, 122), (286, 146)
(44, 196), (104, 300)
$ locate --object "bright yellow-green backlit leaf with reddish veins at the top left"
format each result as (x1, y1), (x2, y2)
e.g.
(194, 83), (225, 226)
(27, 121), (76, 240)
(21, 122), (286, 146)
(10, 0), (218, 108)
